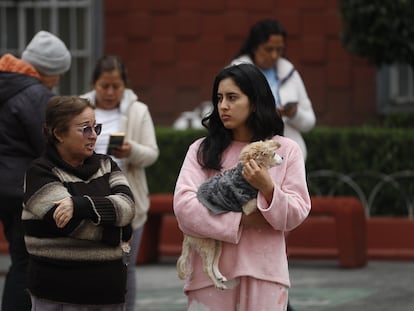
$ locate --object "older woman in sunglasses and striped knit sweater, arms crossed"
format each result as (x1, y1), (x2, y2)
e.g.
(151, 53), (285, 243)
(22, 96), (135, 311)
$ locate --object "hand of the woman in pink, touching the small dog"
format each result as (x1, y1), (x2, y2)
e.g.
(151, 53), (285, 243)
(242, 159), (274, 204)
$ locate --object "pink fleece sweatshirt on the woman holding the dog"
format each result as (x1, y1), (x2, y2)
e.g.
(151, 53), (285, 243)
(174, 136), (311, 290)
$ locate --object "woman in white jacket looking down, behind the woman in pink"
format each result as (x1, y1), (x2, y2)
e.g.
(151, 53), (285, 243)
(231, 19), (316, 160)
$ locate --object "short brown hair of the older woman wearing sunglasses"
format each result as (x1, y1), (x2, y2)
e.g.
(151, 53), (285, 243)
(44, 96), (94, 145)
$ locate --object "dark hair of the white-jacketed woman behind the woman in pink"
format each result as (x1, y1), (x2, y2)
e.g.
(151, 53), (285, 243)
(236, 19), (287, 60)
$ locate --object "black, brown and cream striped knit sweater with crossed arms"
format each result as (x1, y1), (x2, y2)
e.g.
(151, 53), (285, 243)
(22, 146), (134, 305)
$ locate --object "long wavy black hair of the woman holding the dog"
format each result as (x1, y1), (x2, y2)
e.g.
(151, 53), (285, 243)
(197, 64), (283, 170)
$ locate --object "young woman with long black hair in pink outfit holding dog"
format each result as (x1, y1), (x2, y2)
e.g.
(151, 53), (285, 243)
(174, 64), (311, 311)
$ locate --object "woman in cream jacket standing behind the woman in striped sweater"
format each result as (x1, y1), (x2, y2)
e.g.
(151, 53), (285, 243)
(82, 55), (159, 311)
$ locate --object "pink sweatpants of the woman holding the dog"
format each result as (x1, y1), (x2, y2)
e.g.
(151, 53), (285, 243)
(187, 277), (288, 311)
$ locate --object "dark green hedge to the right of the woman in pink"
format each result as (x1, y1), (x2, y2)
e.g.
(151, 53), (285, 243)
(304, 127), (414, 216)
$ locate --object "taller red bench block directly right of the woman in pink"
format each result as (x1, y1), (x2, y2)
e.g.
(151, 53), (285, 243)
(287, 196), (367, 268)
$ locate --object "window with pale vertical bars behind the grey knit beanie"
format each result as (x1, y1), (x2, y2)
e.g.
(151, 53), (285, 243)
(0, 0), (103, 95)
